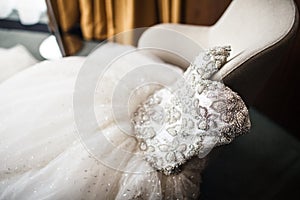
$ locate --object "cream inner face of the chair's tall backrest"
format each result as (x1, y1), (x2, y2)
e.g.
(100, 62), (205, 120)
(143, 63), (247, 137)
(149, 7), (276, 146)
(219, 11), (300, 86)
(209, 0), (296, 56)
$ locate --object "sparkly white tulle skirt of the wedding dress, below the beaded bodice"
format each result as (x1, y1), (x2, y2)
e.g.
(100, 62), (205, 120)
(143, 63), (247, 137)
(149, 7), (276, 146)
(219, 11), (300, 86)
(0, 44), (204, 199)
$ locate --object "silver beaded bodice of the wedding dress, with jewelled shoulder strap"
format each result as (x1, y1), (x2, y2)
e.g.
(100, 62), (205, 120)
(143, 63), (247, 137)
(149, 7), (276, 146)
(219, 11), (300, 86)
(132, 47), (250, 175)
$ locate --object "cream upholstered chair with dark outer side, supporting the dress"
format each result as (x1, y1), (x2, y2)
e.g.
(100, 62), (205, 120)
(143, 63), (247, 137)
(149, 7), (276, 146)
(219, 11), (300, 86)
(138, 0), (298, 105)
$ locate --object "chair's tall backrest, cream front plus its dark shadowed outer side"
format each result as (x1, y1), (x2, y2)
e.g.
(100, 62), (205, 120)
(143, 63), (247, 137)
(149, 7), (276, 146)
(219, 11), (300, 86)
(209, 0), (299, 104)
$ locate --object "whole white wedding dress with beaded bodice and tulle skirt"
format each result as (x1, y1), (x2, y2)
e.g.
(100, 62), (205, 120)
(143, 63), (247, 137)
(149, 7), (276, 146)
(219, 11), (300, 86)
(0, 43), (250, 199)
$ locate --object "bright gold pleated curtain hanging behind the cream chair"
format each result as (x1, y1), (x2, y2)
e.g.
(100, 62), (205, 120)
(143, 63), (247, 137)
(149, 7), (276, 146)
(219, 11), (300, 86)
(52, 0), (182, 40)
